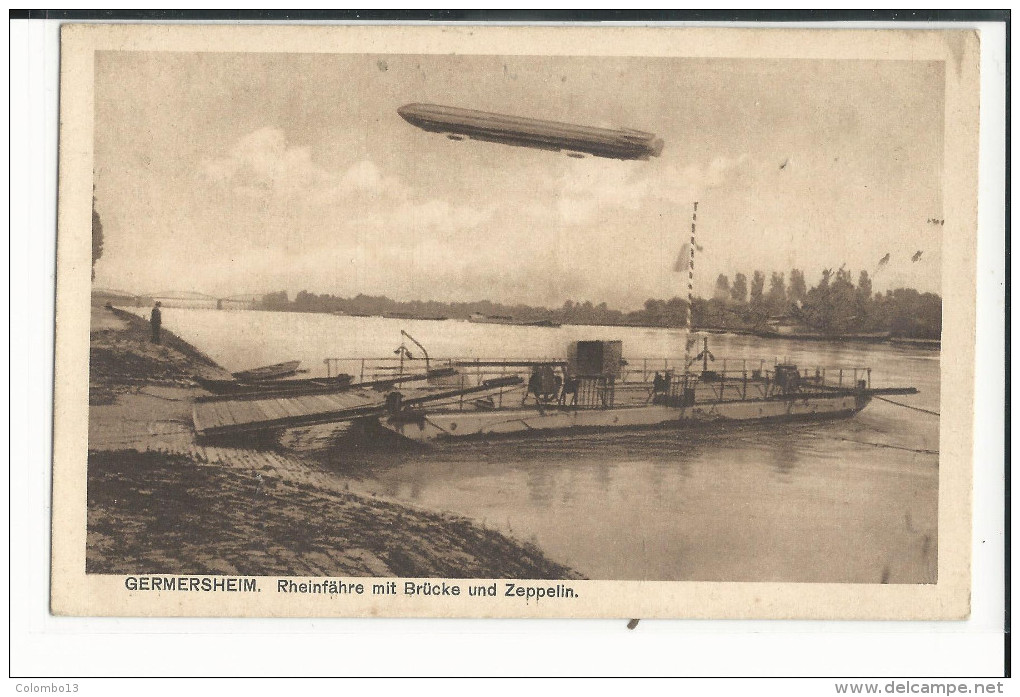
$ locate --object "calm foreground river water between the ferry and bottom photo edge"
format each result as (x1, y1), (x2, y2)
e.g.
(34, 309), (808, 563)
(324, 421), (937, 583)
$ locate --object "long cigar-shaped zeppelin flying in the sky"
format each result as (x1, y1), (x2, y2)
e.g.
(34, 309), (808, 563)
(397, 104), (662, 160)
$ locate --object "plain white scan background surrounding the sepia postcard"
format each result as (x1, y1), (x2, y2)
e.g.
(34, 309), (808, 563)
(0, 13), (1009, 694)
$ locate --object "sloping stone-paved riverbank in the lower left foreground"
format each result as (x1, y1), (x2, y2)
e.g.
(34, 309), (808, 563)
(86, 307), (579, 579)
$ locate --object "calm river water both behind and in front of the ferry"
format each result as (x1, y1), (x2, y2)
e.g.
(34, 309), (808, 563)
(137, 308), (939, 583)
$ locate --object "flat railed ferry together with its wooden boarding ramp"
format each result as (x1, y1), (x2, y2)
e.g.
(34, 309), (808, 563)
(193, 338), (917, 443)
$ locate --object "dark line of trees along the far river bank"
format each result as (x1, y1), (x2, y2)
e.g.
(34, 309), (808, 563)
(259, 267), (941, 339)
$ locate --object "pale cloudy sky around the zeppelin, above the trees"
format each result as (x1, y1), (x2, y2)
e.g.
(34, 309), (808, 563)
(94, 51), (945, 309)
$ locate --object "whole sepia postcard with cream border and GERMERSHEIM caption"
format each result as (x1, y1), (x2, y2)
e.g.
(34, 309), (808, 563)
(53, 27), (976, 618)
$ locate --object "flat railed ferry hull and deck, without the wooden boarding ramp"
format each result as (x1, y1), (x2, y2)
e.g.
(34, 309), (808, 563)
(370, 339), (917, 443)
